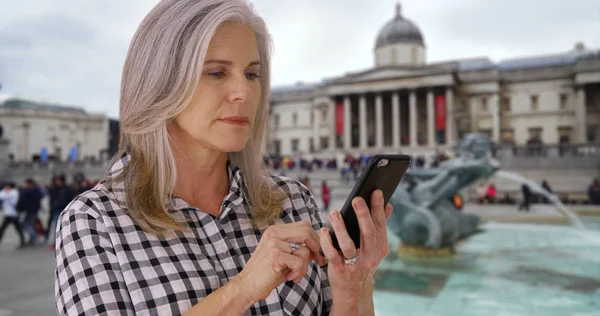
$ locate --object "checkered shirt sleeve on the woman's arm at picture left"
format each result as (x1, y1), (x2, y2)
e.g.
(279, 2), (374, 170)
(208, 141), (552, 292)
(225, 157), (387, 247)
(55, 196), (135, 316)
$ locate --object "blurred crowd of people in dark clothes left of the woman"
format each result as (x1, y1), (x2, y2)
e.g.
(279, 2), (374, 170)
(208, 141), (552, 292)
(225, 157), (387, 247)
(0, 175), (92, 249)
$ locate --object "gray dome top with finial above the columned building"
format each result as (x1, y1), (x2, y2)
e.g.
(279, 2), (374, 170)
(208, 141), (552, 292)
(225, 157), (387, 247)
(375, 3), (425, 49)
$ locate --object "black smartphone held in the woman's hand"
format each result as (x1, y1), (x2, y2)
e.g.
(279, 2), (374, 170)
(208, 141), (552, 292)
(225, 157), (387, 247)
(330, 155), (411, 251)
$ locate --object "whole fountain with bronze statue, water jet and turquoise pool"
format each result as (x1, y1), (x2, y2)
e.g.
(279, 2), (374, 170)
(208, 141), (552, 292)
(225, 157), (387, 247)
(374, 134), (600, 316)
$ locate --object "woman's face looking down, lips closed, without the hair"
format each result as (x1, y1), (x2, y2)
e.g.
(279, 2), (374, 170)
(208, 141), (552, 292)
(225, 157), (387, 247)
(171, 23), (261, 152)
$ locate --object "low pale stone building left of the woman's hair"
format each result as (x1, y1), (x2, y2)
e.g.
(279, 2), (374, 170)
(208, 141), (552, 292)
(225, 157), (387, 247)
(0, 99), (109, 161)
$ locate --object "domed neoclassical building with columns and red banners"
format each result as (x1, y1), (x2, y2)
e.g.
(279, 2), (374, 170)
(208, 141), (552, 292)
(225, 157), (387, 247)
(267, 4), (600, 155)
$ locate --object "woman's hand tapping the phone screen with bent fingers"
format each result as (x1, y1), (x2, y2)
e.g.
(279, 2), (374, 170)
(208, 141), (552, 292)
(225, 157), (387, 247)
(237, 221), (327, 302)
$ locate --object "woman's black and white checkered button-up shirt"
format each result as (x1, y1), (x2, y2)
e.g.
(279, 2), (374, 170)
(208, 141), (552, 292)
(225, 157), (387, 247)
(55, 155), (331, 316)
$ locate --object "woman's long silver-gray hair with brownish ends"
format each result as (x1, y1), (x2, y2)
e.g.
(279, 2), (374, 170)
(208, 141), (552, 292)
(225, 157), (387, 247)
(117, 0), (284, 234)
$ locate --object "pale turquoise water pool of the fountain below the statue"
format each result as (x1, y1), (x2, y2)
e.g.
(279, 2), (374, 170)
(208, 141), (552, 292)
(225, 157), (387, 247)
(375, 220), (600, 315)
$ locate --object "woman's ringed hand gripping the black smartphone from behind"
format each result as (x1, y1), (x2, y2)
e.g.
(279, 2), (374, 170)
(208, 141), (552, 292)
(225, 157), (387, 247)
(320, 190), (392, 309)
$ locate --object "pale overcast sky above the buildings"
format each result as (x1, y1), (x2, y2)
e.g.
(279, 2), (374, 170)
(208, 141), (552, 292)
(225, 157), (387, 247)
(0, 0), (600, 118)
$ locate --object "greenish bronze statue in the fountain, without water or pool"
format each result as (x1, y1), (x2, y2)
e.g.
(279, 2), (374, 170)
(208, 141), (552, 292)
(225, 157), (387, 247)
(388, 134), (499, 252)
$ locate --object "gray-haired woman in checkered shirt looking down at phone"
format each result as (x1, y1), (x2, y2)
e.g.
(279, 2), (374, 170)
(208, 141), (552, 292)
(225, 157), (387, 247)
(56, 0), (391, 315)
